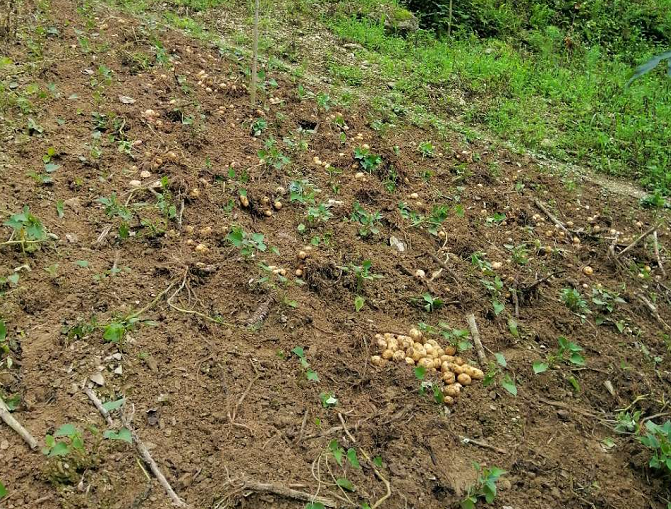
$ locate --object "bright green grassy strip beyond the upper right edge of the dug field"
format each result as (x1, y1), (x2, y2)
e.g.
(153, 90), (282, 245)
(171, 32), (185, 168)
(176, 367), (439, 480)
(326, 16), (671, 193)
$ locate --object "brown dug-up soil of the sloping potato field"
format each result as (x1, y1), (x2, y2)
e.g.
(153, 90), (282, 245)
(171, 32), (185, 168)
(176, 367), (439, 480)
(0, 0), (671, 509)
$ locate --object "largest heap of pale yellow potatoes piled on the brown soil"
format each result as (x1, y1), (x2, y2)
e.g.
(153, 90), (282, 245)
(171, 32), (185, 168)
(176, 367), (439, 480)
(370, 328), (485, 405)
